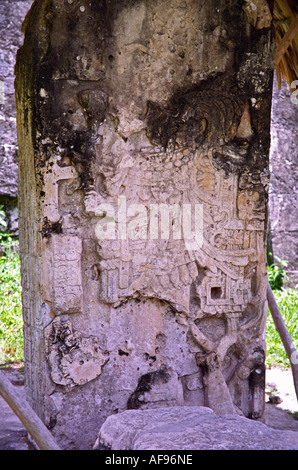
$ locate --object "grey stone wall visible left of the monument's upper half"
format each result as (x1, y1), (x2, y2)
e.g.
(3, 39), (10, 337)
(0, 0), (32, 233)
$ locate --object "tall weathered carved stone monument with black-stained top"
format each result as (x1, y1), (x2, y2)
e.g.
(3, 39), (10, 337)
(16, 0), (274, 448)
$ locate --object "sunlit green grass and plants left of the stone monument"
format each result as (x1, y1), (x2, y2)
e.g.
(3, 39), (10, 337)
(0, 234), (23, 364)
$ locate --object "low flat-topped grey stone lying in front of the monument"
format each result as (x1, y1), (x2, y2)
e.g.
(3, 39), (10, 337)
(94, 406), (298, 450)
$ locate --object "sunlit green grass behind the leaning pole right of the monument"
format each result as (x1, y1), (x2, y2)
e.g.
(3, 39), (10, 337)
(266, 288), (298, 368)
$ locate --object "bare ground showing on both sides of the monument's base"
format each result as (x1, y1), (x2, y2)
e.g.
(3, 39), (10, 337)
(0, 365), (298, 450)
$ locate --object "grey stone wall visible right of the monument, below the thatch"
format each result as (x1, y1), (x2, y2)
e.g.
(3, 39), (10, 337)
(269, 80), (298, 286)
